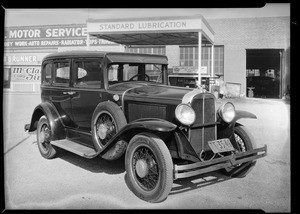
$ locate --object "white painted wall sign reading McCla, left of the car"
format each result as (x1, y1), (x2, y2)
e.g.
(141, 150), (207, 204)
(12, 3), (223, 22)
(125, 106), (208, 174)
(11, 66), (41, 82)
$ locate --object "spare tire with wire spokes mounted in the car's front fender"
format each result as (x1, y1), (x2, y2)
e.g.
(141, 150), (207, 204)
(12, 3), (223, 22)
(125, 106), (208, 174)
(91, 101), (127, 160)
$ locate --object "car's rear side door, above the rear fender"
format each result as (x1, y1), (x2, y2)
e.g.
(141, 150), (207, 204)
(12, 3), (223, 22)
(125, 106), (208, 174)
(50, 59), (74, 127)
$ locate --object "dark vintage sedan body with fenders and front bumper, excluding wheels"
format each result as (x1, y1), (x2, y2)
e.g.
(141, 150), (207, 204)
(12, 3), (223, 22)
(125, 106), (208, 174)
(25, 51), (266, 202)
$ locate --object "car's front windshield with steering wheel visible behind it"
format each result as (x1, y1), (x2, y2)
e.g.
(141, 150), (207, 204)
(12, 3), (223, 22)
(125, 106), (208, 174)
(107, 63), (166, 85)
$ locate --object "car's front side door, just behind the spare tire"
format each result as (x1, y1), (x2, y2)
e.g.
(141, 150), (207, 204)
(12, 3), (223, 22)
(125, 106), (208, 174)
(72, 58), (104, 133)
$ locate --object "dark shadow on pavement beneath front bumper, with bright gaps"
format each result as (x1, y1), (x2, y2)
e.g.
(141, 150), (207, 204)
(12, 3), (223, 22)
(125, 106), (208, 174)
(170, 171), (232, 195)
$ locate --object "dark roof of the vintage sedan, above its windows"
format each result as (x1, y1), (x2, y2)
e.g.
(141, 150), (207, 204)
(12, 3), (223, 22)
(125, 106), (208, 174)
(43, 50), (168, 64)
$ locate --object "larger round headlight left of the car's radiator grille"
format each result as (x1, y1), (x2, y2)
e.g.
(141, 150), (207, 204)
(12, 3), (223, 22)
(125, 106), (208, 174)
(175, 104), (196, 126)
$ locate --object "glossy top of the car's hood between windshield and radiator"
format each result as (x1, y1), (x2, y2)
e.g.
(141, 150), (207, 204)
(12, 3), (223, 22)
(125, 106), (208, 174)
(109, 82), (192, 104)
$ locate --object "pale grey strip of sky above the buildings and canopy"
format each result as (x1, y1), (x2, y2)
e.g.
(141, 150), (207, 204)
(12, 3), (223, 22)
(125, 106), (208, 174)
(5, 3), (290, 27)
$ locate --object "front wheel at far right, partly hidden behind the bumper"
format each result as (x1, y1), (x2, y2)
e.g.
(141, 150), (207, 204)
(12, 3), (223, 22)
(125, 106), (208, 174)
(223, 124), (256, 178)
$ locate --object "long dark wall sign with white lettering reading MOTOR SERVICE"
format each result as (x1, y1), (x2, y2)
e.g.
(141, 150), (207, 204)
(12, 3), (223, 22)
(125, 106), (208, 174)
(4, 25), (116, 48)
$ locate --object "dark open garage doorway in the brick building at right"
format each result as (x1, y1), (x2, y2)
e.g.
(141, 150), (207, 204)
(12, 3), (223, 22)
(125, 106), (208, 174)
(246, 49), (283, 98)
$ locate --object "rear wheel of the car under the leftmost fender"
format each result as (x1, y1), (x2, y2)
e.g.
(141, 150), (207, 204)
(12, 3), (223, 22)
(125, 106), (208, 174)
(37, 115), (56, 159)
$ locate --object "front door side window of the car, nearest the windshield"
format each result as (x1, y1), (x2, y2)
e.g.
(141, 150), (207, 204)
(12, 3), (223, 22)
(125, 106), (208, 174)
(74, 59), (102, 88)
